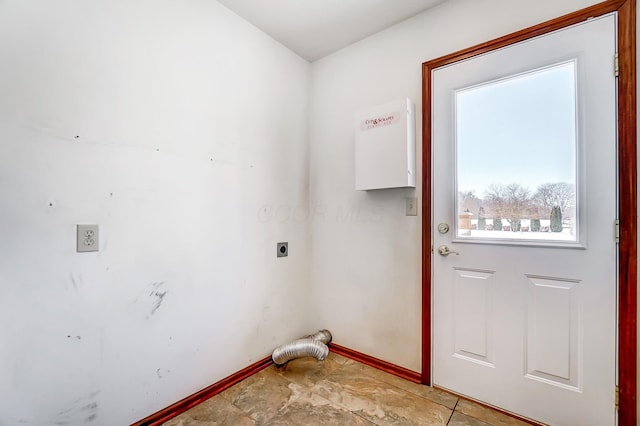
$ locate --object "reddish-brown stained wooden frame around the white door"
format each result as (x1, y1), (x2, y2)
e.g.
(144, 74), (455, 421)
(422, 0), (638, 425)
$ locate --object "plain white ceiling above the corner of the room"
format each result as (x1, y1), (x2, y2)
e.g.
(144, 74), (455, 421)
(218, 0), (446, 61)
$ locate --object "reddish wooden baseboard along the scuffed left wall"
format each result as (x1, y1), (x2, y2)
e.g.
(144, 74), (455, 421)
(131, 356), (273, 426)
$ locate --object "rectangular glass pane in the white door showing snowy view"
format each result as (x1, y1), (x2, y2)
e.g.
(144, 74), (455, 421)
(455, 61), (577, 242)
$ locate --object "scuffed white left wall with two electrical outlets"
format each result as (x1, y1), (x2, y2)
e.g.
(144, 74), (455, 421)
(0, 0), (310, 425)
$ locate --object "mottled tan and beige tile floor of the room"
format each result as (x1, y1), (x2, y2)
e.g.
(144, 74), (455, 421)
(165, 352), (527, 426)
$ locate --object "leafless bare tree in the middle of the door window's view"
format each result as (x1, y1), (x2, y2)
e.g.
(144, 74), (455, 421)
(485, 183), (531, 232)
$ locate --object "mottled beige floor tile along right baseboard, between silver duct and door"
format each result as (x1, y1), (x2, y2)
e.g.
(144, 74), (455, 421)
(312, 369), (451, 425)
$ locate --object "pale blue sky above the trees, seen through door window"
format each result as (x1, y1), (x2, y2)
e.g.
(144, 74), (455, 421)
(455, 62), (576, 198)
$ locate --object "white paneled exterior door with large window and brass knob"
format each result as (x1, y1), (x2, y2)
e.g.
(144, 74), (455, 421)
(432, 15), (617, 425)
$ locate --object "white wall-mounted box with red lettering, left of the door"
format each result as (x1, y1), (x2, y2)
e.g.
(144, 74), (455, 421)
(355, 99), (416, 190)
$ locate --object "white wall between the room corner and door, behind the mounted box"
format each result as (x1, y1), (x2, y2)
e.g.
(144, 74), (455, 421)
(310, 0), (598, 371)
